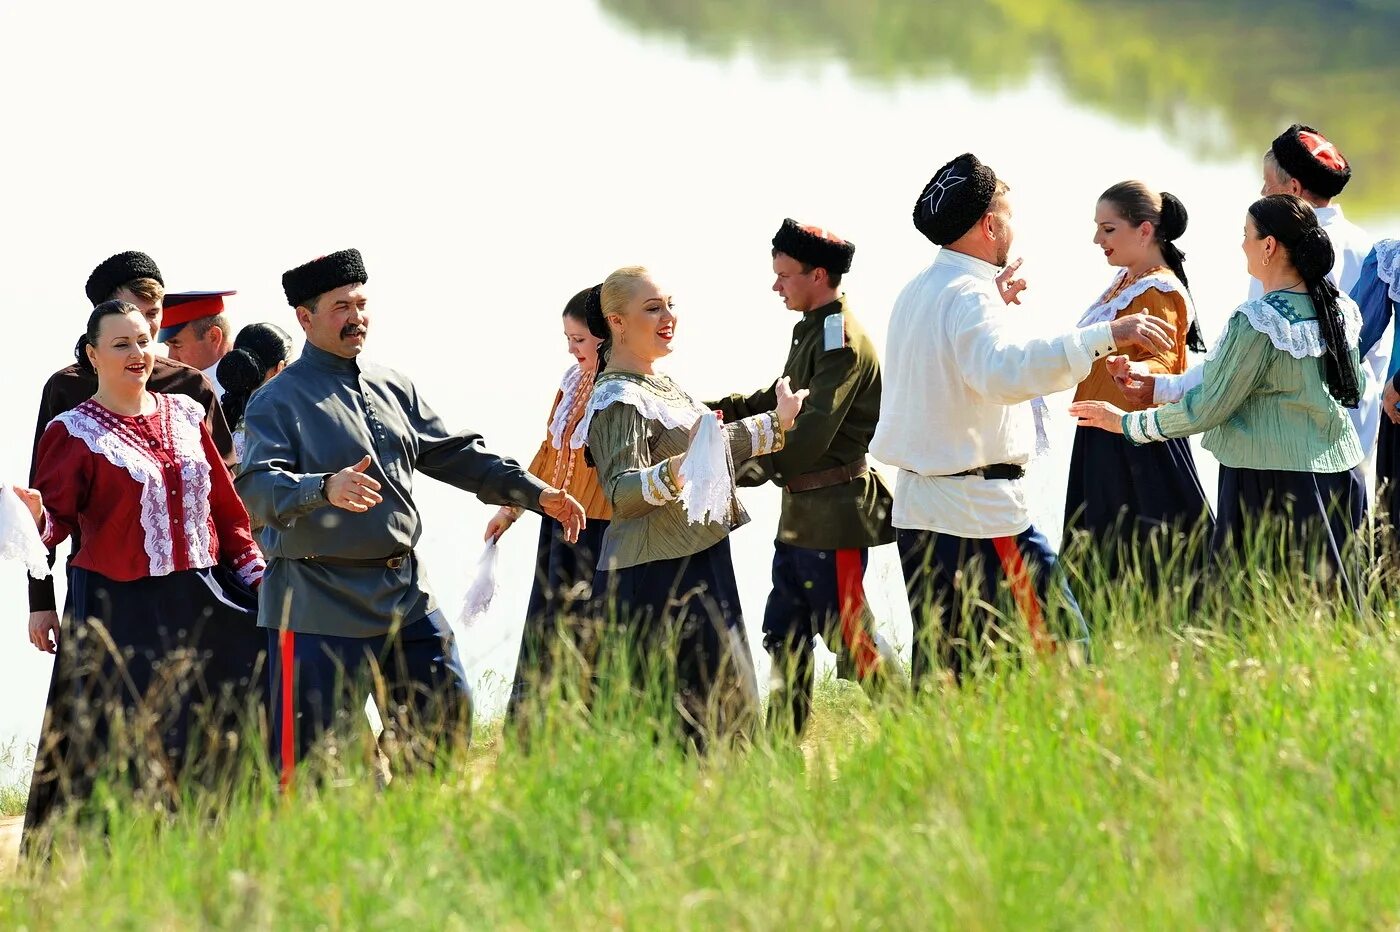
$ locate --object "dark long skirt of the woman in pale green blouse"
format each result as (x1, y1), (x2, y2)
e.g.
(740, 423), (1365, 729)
(1211, 466), (1366, 600)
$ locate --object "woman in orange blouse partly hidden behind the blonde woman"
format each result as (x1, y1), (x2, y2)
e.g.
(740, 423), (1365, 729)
(486, 285), (612, 722)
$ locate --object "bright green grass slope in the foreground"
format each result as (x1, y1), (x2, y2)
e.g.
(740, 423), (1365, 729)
(0, 537), (1400, 929)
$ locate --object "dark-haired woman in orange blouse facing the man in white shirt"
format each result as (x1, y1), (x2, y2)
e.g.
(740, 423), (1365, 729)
(1064, 181), (1211, 579)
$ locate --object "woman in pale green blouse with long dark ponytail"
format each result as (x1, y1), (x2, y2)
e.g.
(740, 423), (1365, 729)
(1070, 195), (1366, 593)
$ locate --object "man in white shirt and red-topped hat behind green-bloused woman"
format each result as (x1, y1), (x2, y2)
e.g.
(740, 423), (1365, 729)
(1249, 123), (1394, 498)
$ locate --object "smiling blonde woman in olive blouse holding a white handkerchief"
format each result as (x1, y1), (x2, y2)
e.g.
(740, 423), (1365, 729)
(585, 266), (806, 751)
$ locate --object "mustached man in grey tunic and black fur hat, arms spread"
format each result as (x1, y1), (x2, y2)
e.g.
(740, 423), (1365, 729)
(237, 249), (585, 786)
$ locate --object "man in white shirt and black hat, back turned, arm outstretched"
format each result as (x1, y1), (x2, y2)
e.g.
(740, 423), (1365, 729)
(871, 154), (1173, 684)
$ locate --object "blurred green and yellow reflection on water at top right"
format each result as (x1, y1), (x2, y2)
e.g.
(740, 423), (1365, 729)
(601, 0), (1400, 216)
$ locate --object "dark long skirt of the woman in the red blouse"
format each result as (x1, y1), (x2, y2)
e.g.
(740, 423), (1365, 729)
(25, 567), (266, 847)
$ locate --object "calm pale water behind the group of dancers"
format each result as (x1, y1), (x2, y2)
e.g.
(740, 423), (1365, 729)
(0, 0), (1400, 761)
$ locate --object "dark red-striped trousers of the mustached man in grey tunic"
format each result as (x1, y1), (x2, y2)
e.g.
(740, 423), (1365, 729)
(267, 612), (472, 788)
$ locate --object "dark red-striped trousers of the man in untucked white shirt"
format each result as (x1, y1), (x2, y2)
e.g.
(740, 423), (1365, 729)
(899, 528), (1089, 687)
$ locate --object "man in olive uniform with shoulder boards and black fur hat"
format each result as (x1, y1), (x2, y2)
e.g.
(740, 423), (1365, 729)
(711, 220), (895, 735)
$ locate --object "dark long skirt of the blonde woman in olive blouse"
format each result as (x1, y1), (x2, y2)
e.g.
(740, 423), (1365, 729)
(594, 539), (759, 753)
